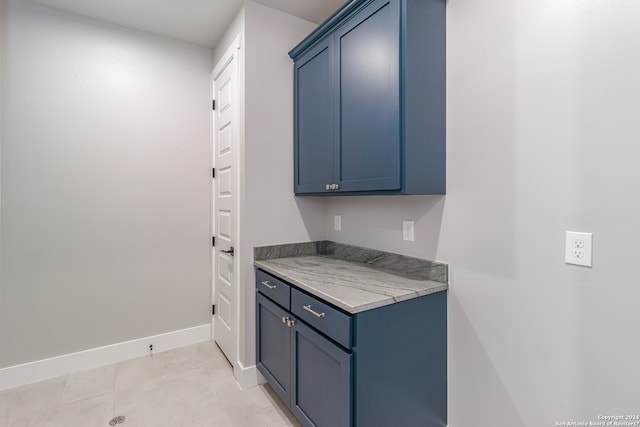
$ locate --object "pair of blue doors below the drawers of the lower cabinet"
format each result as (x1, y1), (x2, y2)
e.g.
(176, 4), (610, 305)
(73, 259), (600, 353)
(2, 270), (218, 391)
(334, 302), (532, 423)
(256, 293), (353, 427)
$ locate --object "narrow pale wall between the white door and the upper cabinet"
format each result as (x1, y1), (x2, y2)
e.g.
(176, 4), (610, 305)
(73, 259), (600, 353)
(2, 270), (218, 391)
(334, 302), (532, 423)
(240, 1), (325, 367)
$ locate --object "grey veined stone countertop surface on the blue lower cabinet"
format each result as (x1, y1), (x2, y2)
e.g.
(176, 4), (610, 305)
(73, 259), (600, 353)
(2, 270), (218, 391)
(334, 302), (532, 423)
(254, 255), (448, 314)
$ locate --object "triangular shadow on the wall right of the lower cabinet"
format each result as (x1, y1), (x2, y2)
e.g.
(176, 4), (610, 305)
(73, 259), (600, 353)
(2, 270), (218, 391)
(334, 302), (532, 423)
(448, 293), (525, 427)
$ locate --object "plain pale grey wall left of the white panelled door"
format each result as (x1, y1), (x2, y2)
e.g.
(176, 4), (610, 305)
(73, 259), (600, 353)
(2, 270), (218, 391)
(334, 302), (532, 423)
(0, 0), (212, 366)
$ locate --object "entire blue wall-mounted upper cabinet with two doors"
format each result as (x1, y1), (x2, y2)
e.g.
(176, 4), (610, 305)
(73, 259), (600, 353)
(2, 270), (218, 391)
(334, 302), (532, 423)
(289, 0), (446, 195)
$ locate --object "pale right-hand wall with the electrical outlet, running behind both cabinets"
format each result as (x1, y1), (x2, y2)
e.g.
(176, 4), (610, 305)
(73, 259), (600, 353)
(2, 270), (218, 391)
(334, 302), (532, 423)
(326, 0), (640, 427)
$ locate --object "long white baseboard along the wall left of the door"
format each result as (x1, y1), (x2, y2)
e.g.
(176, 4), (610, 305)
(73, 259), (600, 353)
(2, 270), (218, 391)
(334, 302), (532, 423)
(0, 324), (211, 390)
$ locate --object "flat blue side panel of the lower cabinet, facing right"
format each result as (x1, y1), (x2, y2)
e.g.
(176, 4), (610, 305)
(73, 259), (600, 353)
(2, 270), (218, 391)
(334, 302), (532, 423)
(353, 292), (447, 427)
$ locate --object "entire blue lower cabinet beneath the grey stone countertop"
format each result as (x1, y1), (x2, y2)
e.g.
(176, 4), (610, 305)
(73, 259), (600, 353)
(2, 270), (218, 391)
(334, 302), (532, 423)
(256, 270), (447, 427)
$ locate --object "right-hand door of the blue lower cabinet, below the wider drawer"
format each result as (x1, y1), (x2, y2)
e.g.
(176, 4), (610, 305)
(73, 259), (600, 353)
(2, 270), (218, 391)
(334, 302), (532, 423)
(291, 322), (353, 427)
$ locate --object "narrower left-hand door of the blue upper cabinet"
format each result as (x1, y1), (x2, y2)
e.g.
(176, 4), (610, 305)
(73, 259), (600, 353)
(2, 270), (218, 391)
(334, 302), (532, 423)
(294, 38), (334, 193)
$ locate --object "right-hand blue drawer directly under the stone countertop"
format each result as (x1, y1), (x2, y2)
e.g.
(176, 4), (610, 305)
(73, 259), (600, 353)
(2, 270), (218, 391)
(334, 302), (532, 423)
(291, 289), (352, 348)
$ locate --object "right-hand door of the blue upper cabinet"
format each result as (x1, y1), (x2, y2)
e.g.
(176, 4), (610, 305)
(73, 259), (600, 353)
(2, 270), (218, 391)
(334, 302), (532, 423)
(334, 0), (402, 192)
